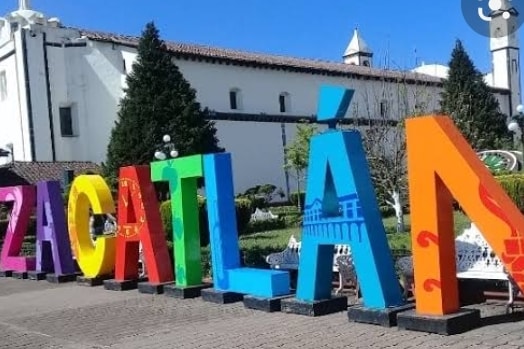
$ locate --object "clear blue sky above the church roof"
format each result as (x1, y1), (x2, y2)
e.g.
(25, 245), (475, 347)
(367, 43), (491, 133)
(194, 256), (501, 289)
(0, 0), (524, 102)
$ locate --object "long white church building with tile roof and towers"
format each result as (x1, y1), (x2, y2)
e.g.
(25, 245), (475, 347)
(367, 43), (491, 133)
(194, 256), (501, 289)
(0, 0), (521, 193)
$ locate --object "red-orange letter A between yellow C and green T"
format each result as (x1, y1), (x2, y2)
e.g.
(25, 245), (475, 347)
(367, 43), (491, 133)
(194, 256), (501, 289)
(115, 166), (173, 284)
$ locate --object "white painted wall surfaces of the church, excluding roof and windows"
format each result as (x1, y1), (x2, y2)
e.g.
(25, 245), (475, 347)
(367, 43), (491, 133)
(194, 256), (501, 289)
(0, 23), (508, 198)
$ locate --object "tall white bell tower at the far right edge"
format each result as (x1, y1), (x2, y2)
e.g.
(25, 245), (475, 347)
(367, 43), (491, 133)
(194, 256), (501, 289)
(489, 0), (521, 113)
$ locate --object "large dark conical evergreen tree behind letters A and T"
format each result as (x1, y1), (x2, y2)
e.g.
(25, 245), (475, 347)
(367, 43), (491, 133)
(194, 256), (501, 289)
(103, 22), (224, 184)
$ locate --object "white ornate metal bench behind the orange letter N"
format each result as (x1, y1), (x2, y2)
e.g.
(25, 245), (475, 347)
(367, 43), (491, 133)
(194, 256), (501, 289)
(396, 223), (519, 310)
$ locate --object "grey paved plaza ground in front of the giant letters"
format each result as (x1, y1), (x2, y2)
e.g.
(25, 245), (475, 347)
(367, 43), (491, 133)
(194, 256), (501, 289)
(0, 278), (524, 349)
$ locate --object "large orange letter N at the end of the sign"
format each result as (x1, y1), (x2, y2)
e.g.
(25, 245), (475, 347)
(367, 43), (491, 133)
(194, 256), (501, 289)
(406, 116), (524, 315)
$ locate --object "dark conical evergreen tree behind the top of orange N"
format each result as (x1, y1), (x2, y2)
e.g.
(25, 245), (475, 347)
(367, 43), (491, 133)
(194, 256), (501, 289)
(440, 40), (511, 151)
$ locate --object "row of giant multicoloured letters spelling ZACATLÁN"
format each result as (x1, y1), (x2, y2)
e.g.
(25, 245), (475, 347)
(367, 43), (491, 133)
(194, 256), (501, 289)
(0, 87), (524, 334)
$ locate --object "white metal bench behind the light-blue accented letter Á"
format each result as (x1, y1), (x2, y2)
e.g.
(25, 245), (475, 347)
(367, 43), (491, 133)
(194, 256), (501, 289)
(266, 235), (358, 299)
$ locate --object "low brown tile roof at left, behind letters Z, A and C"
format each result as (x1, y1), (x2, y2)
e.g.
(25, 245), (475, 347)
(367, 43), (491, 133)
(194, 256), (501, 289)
(0, 161), (101, 187)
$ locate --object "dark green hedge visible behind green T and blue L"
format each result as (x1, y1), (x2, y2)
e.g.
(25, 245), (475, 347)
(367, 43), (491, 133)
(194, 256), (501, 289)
(160, 197), (251, 246)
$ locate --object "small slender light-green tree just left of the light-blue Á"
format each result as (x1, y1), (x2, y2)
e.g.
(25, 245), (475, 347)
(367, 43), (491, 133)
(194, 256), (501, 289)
(284, 123), (318, 209)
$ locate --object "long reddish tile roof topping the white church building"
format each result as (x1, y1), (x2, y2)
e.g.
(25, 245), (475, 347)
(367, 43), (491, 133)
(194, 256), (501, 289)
(77, 28), (508, 89)
